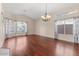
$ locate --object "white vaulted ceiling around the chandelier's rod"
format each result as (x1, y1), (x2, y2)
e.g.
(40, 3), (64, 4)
(2, 3), (79, 19)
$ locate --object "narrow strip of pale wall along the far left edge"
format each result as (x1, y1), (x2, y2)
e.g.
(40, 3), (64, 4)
(0, 3), (5, 47)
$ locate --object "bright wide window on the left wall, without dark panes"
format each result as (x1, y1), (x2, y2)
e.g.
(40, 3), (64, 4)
(5, 20), (27, 36)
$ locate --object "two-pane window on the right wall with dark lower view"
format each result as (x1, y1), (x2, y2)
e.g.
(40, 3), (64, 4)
(56, 19), (73, 34)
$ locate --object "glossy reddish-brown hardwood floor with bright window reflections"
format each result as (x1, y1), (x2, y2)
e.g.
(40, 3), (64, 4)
(3, 35), (79, 56)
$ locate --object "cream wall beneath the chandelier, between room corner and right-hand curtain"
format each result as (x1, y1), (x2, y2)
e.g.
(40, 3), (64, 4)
(35, 18), (54, 38)
